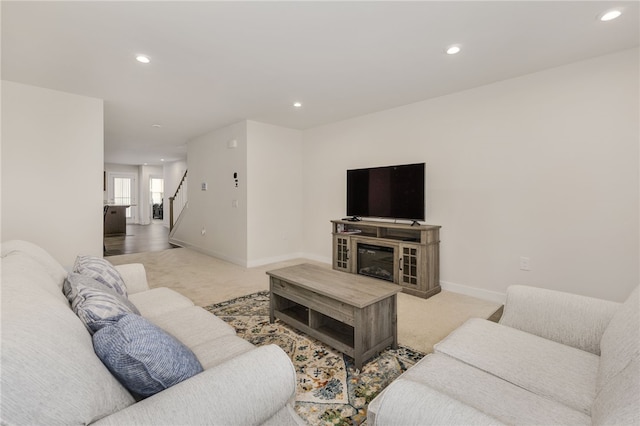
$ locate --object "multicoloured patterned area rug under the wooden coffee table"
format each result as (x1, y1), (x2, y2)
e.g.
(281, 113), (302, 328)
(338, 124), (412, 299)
(205, 291), (424, 425)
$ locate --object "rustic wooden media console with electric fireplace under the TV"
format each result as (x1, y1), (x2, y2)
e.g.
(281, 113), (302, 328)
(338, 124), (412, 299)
(331, 220), (441, 298)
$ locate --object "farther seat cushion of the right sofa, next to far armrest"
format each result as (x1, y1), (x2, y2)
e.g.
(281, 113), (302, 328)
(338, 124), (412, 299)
(434, 318), (599, 415)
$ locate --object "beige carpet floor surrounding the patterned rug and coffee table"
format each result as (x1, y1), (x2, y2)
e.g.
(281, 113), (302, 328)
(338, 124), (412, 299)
(107, 248), (500, 353)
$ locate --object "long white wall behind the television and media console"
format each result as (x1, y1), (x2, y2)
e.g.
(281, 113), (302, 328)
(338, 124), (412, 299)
(302, 49), (640, 301)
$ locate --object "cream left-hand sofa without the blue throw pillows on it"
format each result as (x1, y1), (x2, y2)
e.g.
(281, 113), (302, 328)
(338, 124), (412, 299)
(0, 241), (303, 425)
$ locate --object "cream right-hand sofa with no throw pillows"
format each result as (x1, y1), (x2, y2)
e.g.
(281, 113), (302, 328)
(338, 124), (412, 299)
(367, 286), (640, 426)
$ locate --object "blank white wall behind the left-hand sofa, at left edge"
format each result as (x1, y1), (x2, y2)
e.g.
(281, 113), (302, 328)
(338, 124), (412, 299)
(1, 81), (104, 266)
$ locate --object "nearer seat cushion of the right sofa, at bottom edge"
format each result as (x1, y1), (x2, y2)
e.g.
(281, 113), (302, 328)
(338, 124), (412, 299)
(374, 353), (591, 425)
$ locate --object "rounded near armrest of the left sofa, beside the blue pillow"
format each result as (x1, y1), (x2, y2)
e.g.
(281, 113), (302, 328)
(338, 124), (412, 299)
(95, 345), (296, 426)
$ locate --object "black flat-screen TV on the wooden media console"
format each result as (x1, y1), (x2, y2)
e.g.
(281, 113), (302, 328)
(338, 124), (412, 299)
(347, 163), (425, 220)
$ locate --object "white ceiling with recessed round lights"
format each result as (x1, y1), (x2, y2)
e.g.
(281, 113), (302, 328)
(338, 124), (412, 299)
(1, 1), (640, 164)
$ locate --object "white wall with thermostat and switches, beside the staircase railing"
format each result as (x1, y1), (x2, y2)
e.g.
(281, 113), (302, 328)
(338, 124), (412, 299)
(173, 121), (247, 265)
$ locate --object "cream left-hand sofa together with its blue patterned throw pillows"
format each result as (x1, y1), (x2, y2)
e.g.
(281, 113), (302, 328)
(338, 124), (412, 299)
(0, 241), (303, 425)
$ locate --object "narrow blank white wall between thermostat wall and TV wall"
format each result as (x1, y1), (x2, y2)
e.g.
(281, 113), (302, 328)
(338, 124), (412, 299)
(246, 121), (303, 266)
